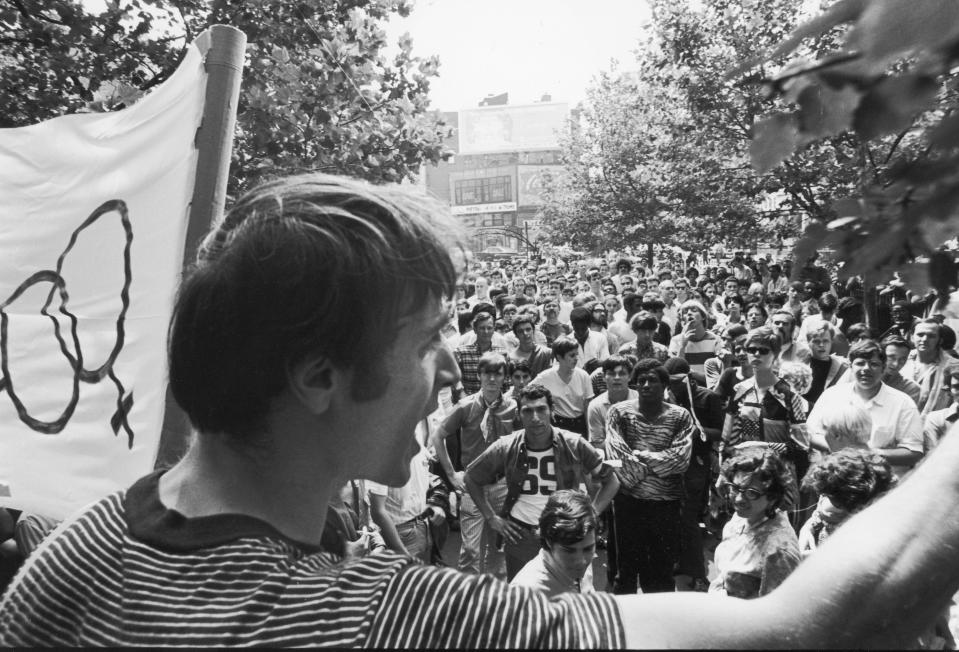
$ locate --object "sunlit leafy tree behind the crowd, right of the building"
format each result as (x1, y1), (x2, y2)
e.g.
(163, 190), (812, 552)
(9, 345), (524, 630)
(544, 0), (948, 270)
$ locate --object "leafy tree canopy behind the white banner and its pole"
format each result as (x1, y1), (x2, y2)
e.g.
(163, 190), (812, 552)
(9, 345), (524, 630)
(0, 0), (451, 192)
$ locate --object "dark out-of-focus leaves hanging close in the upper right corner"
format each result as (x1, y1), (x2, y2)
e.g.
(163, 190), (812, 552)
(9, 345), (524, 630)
(731, 0), (959, 294)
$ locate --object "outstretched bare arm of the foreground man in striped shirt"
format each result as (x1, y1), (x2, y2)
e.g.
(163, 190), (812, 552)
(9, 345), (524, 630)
(618, 420), (959, 648)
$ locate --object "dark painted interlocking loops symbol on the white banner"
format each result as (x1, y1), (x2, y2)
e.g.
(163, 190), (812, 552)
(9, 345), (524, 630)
(0, 199), (133, 448)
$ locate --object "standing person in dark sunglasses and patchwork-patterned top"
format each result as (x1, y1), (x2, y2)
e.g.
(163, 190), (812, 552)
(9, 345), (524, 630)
(720, 326), (809, 528)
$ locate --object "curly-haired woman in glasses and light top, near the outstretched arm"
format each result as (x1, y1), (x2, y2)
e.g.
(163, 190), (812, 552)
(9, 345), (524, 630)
(709, 444), (802, 599)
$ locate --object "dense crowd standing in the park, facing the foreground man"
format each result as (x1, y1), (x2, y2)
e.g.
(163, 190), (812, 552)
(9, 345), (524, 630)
(412, 242), (959, 644)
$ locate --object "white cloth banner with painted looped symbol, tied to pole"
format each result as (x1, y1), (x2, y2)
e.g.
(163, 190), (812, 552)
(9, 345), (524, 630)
(0, 37), (208, 518)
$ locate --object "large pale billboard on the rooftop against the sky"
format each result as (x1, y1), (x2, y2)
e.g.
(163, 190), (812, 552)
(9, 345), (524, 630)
(457, 102), (569, 154)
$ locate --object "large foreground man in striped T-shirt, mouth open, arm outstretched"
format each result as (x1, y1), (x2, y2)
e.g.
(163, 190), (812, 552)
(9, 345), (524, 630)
(0, 175), (959, 649)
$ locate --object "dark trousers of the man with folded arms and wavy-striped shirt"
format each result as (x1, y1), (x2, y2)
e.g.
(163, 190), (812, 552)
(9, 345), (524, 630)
(613, 493), (682, 594)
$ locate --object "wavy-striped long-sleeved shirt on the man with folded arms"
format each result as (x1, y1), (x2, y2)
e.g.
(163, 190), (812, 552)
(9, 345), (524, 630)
(606, 400), (696, 500)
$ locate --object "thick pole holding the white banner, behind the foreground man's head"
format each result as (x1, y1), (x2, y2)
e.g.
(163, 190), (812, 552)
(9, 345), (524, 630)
(155, 25), (246, 467)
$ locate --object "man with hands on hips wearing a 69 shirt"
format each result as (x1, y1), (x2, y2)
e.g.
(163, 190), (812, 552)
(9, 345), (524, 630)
(465, 383), (619, 579)
